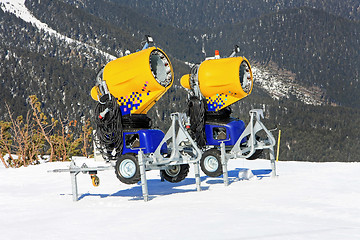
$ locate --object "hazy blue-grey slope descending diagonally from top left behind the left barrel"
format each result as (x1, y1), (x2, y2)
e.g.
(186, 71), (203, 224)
(56, 0), (204, 61)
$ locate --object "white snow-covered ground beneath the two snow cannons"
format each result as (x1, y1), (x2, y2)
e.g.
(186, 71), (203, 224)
(0, 158), (360, 240)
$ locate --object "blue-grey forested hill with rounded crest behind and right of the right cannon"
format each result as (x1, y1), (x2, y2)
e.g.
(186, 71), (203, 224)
(204, 8), (360, 108)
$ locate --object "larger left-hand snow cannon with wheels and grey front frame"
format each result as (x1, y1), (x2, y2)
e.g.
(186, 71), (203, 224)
(91, 36), (202, 189)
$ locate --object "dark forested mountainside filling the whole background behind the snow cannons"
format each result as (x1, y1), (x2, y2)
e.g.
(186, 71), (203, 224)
(0, 0), (360, 161)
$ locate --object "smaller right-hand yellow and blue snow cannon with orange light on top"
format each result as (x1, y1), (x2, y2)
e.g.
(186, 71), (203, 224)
(180, 46), (275, 177)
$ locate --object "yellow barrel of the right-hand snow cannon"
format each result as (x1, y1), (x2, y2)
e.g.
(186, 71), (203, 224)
(180, 57), (253, 111)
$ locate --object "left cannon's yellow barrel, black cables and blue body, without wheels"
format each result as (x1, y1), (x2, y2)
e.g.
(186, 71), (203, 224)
(91, 36), (174, 169)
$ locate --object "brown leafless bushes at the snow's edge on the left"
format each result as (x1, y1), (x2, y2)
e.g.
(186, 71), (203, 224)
(0, 95), (92, 167)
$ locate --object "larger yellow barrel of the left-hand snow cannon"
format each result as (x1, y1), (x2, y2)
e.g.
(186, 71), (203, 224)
(92, 47), (174, 115)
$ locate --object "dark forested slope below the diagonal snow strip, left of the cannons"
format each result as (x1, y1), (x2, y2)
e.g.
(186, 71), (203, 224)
(0, 1), (115, 118)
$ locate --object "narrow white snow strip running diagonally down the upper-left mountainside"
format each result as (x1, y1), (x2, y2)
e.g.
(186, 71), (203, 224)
(0, 0), (116, 60)
